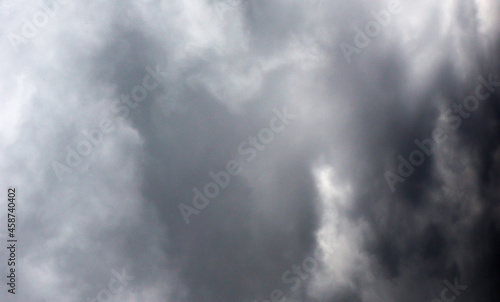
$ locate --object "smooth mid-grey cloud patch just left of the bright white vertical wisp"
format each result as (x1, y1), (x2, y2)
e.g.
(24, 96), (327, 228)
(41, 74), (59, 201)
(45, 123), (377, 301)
(137, 82), (316, 301)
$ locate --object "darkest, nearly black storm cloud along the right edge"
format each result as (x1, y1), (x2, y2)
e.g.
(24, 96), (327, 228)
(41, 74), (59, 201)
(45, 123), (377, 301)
(304, 1), (498, 301)
